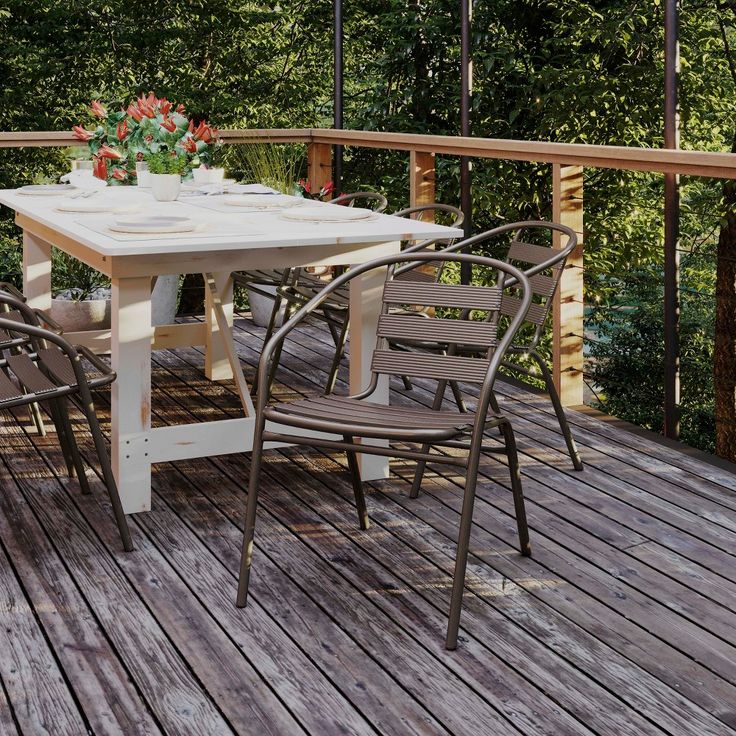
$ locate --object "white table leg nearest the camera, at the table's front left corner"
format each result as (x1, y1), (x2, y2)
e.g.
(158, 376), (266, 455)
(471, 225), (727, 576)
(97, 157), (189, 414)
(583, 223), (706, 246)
(111, 277), (153, 514)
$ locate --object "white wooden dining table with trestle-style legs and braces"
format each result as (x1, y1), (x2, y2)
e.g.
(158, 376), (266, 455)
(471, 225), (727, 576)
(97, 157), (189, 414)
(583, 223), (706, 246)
(0, 187), (462, 513)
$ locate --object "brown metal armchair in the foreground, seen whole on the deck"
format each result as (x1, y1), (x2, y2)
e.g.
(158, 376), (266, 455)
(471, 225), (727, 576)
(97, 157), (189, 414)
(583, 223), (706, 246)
(237, 251), (532, 649)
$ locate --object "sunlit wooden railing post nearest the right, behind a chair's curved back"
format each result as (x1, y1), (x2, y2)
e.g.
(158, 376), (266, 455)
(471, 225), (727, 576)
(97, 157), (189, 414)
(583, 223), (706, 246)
(552, 164), (584, 406)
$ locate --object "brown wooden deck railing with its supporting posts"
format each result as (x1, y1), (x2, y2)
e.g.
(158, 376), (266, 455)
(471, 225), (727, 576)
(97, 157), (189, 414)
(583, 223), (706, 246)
(5, 123), (736, 406)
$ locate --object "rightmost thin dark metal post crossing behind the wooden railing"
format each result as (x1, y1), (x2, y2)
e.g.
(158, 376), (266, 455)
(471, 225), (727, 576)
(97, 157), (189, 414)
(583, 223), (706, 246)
(664, 0), (680, 439)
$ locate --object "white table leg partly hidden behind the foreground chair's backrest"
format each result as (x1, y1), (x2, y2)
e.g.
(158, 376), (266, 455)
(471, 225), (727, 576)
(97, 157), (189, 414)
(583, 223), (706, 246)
(350, 253), (400, 480)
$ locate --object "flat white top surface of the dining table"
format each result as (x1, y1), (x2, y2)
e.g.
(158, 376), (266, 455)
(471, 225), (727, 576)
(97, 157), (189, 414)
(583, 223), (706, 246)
(0, 187), (463, 258)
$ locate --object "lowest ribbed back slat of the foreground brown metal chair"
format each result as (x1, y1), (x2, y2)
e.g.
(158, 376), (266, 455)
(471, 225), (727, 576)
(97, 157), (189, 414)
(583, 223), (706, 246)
(371, 350), (489, 383)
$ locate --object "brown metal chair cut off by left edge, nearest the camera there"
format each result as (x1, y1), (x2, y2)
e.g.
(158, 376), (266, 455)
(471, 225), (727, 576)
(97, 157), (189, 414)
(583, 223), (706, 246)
(0, 292), (133, 551)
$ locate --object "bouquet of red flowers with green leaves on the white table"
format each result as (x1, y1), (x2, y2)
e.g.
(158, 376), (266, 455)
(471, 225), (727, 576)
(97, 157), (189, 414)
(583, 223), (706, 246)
(72, 92), (220, 184)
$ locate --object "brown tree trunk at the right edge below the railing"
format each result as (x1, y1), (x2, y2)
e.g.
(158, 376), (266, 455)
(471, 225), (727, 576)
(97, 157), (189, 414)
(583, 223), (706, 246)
(713, 175), (736, 461)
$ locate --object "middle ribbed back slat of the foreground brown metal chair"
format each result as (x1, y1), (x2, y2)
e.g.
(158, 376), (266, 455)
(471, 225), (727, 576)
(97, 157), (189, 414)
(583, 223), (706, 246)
(378, 314), (497, 347)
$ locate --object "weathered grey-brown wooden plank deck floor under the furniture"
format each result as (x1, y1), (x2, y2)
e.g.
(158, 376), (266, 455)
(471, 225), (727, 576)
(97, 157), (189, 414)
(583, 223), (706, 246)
(0, 319), (736, 736)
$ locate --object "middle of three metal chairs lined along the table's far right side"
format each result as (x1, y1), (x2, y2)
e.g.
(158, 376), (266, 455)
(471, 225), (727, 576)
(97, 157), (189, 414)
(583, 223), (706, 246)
(265, 204), (465, 394)
